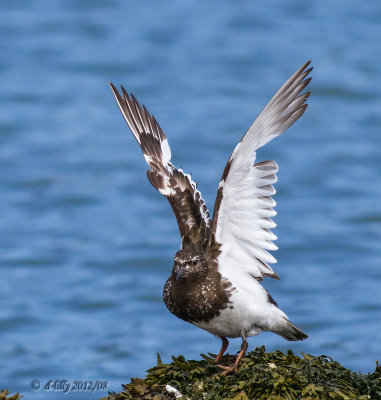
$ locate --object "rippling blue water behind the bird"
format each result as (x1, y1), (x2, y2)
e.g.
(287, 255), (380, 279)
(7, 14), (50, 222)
(0, 0), (381, 399)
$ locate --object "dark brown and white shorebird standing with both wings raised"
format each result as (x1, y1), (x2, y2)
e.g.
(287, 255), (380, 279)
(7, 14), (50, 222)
(110, 62), (312, 374)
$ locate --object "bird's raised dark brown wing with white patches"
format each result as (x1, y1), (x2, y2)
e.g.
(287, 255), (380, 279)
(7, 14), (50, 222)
(110, 83), (211, 241)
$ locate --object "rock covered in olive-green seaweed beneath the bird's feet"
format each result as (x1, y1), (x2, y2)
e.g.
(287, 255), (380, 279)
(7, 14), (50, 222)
(101, 347), (381, 400)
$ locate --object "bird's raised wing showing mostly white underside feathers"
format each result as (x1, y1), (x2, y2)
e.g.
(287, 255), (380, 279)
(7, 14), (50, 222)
(212, 62), (312, 280)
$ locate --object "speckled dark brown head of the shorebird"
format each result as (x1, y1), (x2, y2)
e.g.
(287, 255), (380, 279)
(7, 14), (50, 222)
(172, 250), (208, 281)
